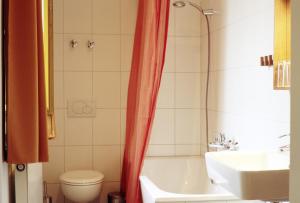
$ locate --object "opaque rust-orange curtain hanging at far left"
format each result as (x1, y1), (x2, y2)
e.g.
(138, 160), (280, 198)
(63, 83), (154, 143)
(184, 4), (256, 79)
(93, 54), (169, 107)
(5, 0), (48, 163)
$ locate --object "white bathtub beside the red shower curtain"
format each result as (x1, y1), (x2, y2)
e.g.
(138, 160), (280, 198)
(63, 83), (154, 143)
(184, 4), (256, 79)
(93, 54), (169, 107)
(140, 157), (260, 203)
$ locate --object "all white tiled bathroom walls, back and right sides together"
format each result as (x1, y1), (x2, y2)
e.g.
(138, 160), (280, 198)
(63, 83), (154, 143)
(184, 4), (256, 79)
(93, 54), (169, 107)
(44, 0), (289, 203)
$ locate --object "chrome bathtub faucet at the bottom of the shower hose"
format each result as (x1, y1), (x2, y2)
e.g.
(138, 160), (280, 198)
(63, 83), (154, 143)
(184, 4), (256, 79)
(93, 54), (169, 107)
(209, 133), (239, 151)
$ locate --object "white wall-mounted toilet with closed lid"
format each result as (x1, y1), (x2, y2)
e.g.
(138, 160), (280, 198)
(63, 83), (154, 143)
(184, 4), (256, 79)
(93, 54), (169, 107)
(59, 170), (104, 202)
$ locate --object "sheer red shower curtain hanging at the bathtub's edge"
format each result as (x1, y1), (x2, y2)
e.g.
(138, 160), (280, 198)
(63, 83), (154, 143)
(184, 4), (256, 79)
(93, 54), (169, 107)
(121, 0), (170, 203)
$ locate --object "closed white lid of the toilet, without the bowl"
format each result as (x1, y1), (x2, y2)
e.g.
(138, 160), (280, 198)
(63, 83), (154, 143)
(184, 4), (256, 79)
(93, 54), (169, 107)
(59, 170), (104, 185)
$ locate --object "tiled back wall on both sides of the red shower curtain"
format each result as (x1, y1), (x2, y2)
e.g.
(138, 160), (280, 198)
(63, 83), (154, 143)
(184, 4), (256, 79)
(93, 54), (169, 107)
(44, 0), (204, 203)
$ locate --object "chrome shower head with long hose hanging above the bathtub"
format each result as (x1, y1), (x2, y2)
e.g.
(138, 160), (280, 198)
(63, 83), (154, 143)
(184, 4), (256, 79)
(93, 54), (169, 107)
(173, 0), (216, 151)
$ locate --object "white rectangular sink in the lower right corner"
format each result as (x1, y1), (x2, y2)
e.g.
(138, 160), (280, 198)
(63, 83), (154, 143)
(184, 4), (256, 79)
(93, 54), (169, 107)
(205, 151), (290, 201)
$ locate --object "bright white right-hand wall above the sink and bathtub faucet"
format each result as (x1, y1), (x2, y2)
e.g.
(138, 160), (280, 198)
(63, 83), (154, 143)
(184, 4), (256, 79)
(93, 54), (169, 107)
(201, 0), (290, 152)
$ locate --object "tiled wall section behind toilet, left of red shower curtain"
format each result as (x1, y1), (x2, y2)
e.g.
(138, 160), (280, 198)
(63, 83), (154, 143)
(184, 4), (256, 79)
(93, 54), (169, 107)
(44, 0), (137, 203)
